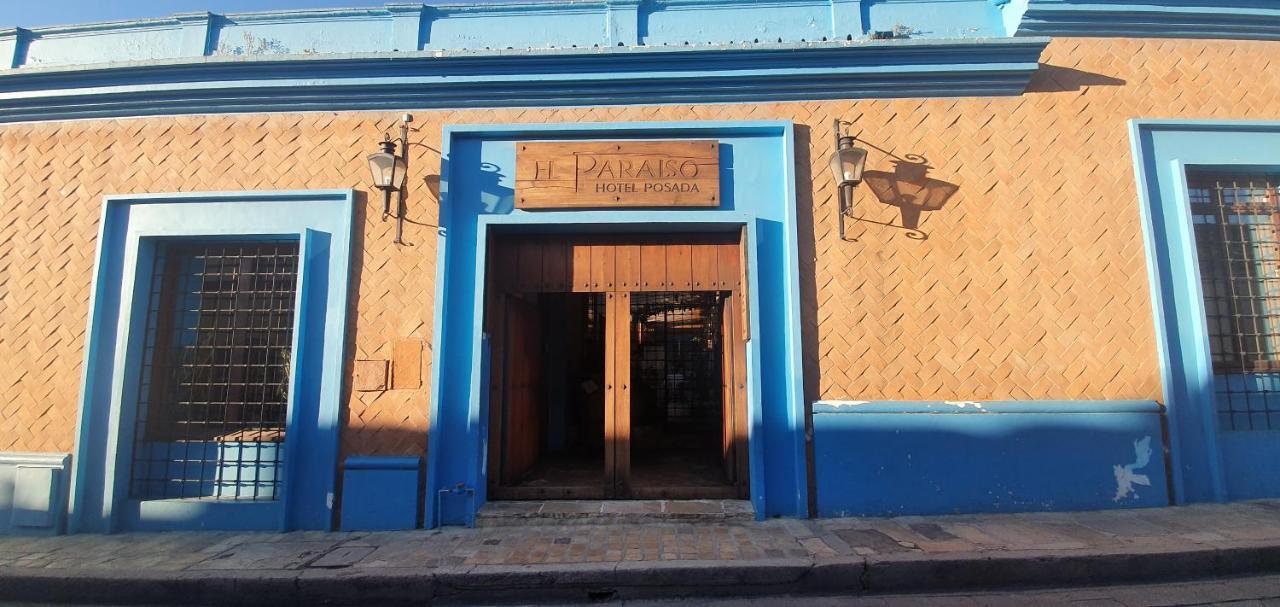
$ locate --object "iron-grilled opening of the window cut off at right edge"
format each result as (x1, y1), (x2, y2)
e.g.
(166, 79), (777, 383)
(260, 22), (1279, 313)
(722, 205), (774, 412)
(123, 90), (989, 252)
(1188, 172), (1280, 430)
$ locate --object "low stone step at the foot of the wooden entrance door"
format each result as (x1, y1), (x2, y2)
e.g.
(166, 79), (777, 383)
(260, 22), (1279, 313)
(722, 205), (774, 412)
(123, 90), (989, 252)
(476, 499), (755, 526)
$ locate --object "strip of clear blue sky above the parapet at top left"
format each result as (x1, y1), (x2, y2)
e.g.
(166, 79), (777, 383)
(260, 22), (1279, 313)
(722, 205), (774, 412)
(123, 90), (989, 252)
(0, 0), (519, 28)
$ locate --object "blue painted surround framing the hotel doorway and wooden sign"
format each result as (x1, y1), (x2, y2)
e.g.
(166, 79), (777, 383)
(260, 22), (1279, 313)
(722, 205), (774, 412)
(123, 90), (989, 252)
(424, 120), (808, 528)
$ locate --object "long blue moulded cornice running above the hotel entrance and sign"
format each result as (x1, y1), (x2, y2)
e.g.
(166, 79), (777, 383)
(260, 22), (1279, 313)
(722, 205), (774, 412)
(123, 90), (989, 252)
(0, 38), (1048, 122)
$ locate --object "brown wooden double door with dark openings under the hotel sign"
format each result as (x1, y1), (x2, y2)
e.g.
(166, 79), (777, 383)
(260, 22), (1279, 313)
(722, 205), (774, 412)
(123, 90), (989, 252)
(485, 233), (749, 499)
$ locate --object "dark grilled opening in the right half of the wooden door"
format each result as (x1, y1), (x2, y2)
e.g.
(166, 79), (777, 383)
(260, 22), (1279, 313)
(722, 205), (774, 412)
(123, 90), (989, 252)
(631, 292), (723, 425)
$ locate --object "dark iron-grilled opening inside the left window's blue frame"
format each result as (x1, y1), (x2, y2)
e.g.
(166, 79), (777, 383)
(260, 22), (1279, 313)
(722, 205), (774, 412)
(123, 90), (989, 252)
(131, 242), (298, 499)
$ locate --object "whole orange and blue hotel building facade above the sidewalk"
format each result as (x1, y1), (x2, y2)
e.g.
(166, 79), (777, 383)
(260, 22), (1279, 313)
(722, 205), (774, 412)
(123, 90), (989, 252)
(0, 0), (1280, 533)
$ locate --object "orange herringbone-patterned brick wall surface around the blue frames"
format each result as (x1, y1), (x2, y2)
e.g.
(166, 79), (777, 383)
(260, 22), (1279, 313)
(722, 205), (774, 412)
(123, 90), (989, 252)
(0, 40), (1280, 455)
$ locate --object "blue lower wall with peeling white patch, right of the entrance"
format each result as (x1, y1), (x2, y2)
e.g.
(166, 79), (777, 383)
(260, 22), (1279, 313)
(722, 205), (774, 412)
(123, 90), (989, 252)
(813, 401), (1169, 516)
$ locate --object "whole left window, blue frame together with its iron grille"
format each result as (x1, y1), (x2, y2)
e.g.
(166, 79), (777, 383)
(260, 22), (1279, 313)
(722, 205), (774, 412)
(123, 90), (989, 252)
(69, 191), (353, 531)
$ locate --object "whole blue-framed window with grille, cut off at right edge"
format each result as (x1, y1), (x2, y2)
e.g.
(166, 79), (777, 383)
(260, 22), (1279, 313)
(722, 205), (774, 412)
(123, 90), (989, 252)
(1130, 120), (1280, 503)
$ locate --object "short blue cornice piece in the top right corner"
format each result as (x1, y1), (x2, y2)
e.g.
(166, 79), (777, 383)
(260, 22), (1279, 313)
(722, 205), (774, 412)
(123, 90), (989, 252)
(1016, 0), (1280, 40)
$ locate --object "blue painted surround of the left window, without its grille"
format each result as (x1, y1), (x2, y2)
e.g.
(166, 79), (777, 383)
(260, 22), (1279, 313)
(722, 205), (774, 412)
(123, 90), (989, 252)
(70, 190), (353, 531)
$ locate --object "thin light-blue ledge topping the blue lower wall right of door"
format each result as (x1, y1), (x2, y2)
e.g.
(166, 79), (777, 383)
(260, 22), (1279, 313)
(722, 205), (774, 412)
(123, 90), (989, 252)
(813, 401), (1162, 415)
